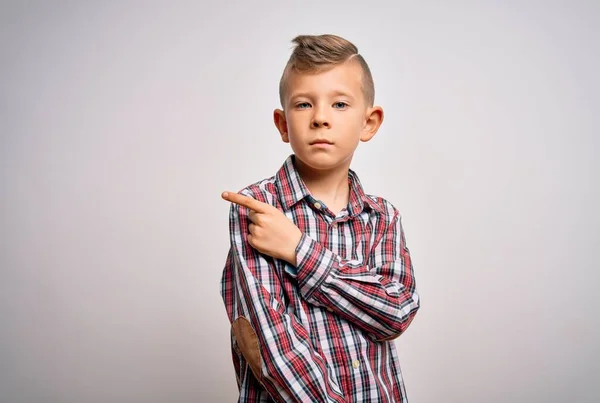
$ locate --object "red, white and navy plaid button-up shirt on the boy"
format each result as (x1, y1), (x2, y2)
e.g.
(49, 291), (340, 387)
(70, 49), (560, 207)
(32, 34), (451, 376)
(221, 155), (419, 402)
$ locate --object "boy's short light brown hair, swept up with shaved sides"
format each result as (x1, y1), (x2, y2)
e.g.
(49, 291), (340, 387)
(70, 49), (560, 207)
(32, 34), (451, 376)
(279, 34), (375, 107)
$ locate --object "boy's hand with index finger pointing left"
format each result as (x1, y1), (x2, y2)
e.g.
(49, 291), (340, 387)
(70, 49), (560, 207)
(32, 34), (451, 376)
(221, 192), (302, 266)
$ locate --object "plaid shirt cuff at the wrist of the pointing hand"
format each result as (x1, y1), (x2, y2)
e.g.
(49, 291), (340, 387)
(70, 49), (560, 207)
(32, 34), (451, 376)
(296, 234), (336, 299)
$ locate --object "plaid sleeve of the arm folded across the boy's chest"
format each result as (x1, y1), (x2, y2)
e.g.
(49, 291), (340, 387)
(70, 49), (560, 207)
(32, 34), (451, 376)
(288, 208), (419, 341)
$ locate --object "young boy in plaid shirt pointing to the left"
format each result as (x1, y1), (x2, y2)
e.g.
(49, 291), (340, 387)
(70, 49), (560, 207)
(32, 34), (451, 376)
(221, 35), (419, 402)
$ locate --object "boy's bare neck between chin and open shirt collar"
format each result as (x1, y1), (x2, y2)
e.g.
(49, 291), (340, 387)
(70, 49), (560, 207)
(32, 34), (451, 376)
(296, 158), (350, 212)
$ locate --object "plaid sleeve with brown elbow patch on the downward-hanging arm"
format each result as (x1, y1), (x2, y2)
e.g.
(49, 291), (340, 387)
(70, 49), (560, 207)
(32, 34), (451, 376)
(226, 200), (344, 402)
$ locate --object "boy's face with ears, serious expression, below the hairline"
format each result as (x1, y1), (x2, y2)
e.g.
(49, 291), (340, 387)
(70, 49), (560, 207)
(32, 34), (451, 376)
(275, 62), (383, 170)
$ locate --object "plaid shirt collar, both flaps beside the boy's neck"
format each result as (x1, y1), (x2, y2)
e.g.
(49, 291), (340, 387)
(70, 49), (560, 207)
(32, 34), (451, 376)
(275, 154), (385, 216)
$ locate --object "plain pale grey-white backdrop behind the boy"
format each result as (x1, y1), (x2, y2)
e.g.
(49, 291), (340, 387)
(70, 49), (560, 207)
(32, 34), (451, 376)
(0, 0), (600, 403)
